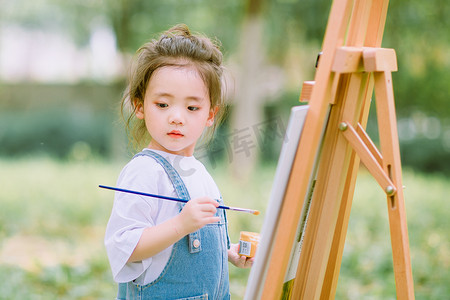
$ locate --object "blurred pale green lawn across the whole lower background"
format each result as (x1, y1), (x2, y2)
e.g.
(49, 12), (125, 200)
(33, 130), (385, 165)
(0, 158), (450, 299)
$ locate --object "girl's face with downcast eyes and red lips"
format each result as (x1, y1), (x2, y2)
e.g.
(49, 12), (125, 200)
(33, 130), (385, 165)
(136, 66), (216, 156)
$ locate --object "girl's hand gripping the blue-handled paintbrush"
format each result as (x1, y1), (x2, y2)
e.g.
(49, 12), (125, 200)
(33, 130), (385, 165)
(176, 197), (220, 235)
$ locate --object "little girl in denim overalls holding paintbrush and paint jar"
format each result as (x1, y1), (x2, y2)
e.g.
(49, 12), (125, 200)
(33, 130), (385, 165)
(105, 25), (253, 299)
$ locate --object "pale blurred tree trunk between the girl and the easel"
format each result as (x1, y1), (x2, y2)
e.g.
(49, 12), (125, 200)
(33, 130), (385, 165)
(227, 0), (265, 179)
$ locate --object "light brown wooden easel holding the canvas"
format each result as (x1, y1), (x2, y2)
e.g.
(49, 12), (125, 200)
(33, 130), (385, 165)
(253, 0), (414, 300)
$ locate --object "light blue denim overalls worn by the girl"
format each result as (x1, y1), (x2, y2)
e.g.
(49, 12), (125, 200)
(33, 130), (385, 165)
(117, 150), (230, 300)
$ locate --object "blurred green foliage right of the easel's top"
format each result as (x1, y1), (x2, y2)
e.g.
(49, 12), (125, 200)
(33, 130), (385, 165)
(383, 0), (450, 120)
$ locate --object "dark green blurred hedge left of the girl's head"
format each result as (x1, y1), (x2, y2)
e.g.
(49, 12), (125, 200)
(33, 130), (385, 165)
(0, 108), (112, 158)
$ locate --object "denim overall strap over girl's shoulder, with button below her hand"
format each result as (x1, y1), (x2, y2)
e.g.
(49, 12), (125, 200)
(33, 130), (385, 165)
(134, 149), (202, 253)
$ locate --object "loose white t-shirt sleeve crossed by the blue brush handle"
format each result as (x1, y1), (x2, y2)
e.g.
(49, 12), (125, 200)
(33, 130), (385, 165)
(105, 157), (164, 282)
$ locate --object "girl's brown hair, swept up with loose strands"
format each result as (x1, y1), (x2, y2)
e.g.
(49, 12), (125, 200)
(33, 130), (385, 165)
(121, 24), (224, 149)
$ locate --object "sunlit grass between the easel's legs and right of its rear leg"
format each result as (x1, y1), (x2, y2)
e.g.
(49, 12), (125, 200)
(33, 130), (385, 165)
(336, 171), (450, 299)
